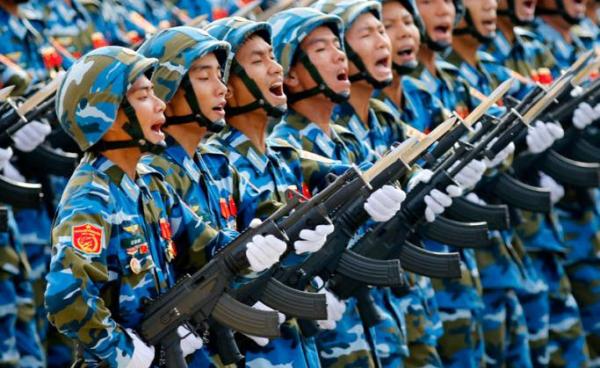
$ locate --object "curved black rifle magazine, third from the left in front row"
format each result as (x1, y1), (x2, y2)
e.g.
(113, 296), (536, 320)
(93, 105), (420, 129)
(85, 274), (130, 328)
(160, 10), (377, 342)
(337, 249), (404, 287)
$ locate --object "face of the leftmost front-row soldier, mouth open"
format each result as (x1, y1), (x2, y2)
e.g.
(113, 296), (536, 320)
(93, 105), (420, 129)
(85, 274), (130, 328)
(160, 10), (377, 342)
(127, 75), (165, 144)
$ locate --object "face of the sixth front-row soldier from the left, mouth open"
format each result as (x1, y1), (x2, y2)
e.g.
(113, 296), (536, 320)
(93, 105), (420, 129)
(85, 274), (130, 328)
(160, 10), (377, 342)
(382, 1), (421, 65)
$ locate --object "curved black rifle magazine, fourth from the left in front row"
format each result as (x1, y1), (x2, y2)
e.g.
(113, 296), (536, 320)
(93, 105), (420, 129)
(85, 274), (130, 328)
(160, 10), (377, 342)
(399, 242), (461, 279)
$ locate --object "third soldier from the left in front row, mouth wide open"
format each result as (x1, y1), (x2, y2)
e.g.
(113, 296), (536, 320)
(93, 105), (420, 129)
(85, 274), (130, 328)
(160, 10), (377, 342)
(208, 18), (406, 366)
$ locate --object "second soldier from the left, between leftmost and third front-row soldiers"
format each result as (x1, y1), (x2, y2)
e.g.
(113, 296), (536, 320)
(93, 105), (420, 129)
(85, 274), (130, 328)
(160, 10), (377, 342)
(140, 27), (342, 366)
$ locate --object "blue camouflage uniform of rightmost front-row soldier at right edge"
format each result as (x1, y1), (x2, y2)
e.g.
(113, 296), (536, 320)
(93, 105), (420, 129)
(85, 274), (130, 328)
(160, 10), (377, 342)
(534, 15), (600, 365)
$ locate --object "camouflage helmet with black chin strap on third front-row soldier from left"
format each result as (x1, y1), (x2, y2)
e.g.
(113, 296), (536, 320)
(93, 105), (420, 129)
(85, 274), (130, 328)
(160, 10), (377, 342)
(205, 17), (286, 118)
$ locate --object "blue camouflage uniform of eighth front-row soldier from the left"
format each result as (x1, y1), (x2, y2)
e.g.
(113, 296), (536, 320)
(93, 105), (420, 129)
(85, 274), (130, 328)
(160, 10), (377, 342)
(446, 51), (531, 367)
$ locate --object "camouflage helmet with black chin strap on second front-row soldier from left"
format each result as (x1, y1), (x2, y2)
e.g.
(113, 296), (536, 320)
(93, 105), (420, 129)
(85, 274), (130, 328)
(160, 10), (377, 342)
(139, 26), (230, 132)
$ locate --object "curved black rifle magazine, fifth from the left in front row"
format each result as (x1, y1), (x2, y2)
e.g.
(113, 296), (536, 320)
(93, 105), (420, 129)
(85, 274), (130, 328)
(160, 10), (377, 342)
(418, 216), (492, 248)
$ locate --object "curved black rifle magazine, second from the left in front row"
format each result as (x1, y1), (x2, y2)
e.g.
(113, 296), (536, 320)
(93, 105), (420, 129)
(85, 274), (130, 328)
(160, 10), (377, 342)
(260, 277), (327, 320)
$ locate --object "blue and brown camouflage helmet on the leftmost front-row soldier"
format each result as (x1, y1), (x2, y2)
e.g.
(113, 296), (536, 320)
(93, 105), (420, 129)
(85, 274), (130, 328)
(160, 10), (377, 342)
(56, 46), (158, 151)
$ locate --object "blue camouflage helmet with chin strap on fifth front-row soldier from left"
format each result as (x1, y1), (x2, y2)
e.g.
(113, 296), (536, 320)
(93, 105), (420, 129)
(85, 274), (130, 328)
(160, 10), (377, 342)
(313, 0), (392, 89)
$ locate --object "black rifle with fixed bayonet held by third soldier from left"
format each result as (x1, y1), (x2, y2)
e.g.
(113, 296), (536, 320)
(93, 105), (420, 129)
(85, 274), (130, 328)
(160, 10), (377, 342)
(329, 75), (576, 323)
